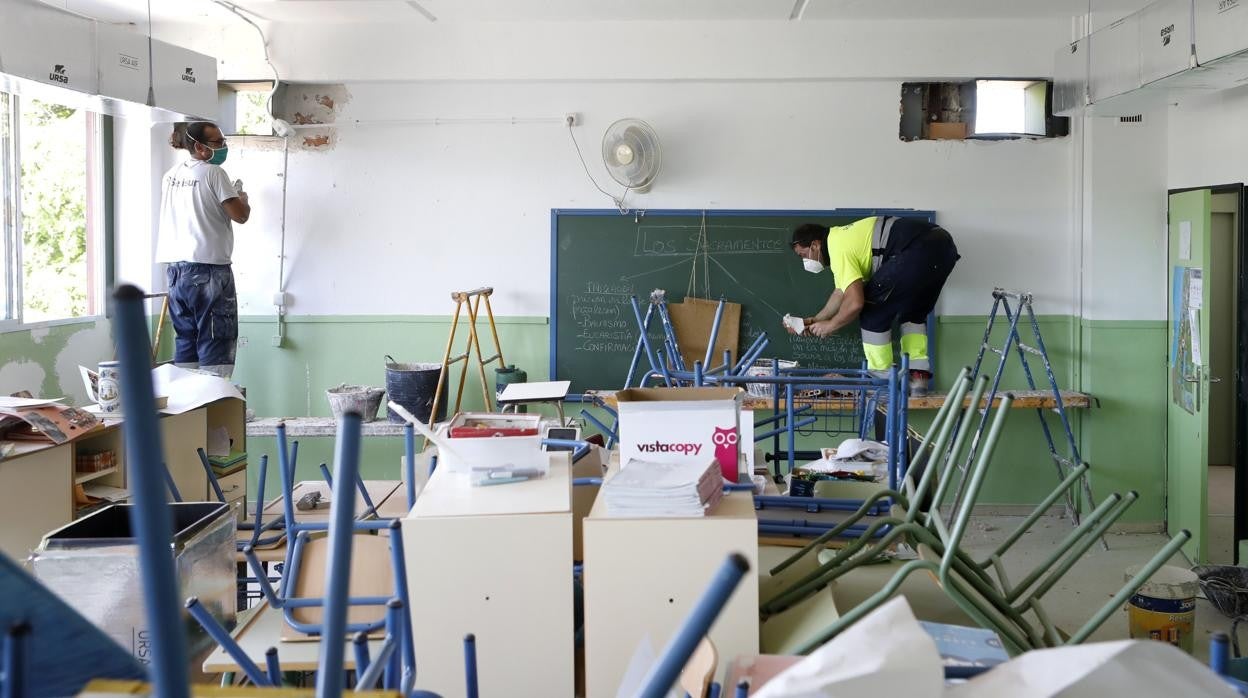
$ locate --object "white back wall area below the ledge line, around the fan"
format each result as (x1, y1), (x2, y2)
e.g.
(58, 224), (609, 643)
(197, 81), (1075, 315)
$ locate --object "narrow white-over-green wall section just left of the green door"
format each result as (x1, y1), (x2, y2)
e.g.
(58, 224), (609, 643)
(1072, 110), (1168, 523)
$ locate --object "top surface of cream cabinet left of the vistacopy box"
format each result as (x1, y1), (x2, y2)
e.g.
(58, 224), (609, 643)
(407, 452), (572, 519)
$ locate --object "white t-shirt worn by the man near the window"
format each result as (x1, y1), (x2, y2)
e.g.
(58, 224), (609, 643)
(156, 157), (238, 265)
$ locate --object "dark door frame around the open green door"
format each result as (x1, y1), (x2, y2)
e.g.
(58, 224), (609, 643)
(1166, 184), (1248, 564)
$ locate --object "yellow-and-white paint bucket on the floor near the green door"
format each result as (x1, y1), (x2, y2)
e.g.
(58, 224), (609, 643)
(1126, 564), (1201, 654)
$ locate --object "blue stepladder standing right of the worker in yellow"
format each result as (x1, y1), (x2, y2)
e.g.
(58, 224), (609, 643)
(952, 288), (1109, 549)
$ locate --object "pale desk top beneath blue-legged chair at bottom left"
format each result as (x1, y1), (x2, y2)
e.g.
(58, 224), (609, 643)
(203, 603), (382, 674)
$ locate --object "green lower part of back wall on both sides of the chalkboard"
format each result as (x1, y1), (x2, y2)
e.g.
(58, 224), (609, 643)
(235, 316), (1164, 522)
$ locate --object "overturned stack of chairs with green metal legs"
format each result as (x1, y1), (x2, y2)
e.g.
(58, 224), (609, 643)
(761, 370), (1189, 654)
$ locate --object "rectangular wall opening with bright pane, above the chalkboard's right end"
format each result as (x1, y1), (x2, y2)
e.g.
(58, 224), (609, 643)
(900, 80), (1070, 141)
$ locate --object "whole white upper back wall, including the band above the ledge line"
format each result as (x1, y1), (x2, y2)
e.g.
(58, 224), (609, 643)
(109, 15), (1077, 316)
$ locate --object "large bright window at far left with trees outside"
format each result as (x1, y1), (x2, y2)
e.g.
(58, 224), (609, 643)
(0, 92), (105, 326)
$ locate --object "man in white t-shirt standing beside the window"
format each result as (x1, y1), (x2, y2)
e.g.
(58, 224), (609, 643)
(156, 121), (251, 378)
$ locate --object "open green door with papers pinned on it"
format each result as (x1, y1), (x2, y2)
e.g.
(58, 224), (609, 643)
(1166, 190), (1212, 562)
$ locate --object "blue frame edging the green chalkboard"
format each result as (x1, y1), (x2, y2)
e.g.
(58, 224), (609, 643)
(548, 209), (936, 387)
